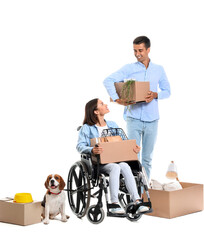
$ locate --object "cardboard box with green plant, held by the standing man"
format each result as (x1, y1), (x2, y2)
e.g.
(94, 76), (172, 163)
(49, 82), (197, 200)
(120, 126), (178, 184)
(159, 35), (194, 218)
(111, 81), (150, 103)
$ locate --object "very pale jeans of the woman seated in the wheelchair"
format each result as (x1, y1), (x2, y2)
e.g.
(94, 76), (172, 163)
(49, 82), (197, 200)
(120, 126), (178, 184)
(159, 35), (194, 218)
(100, 162), (140, 203)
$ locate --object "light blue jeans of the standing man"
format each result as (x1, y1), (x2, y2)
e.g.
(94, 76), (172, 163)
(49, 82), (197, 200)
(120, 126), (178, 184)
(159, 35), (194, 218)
(126, 117), (158, 180)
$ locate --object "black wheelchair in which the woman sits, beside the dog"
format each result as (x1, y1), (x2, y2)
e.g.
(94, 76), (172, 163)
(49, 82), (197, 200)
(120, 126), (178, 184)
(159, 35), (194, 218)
(66, 128), (152, 224)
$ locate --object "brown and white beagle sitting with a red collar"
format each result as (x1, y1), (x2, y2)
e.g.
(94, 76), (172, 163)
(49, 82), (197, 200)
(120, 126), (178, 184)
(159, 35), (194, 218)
(41, 174), (69, 224)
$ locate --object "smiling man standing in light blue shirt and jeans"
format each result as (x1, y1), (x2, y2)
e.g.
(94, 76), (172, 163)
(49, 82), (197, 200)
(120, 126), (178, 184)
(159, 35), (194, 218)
(104, 36), (170, 180)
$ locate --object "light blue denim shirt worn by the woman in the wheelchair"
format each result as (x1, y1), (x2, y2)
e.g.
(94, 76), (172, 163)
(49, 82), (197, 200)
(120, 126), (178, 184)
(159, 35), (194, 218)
(76, 121), (118, 154)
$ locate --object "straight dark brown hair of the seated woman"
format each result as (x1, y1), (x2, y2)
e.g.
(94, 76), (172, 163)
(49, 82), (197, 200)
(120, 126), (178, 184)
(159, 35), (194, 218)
(83, 98), (98, 126)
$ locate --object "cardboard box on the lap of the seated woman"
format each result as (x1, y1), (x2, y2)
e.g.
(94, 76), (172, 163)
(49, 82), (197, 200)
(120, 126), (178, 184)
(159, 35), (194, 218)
(91, 139), (138, 164)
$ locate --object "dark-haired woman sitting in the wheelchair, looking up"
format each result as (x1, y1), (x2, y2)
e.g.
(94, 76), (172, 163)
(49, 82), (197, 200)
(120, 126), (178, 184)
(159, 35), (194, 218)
(77, 98), (149, 214)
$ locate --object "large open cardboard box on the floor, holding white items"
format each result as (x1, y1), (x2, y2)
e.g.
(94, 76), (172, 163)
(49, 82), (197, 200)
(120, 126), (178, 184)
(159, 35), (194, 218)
(144, 182), (203, 218)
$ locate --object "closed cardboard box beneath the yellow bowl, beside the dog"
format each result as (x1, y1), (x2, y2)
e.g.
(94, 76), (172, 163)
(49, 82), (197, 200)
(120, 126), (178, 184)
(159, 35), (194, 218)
(0, 199), (41, 226)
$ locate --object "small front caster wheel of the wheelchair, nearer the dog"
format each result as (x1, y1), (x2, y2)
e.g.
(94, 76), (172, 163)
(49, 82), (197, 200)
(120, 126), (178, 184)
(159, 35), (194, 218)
(86, 205), (105, 224)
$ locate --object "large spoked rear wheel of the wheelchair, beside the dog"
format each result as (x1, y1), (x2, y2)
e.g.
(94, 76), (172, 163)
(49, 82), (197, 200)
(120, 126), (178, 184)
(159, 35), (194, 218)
(67, 161), (91, 218)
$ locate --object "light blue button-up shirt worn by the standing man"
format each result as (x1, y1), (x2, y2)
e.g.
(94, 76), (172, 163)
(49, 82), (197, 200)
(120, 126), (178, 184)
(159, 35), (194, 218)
(103, 61), (171, 122)
